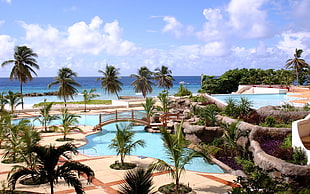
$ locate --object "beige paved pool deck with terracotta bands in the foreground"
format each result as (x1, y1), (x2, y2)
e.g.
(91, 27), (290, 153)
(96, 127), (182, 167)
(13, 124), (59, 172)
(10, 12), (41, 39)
(0, 120), (236, 194)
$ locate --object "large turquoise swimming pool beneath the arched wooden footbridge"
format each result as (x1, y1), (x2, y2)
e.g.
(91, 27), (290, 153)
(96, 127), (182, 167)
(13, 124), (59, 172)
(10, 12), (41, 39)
(20, 115), (224, 173)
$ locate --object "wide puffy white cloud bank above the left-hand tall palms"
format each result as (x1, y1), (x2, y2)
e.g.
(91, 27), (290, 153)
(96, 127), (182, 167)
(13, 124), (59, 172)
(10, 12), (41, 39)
(21, 16), (136, 56)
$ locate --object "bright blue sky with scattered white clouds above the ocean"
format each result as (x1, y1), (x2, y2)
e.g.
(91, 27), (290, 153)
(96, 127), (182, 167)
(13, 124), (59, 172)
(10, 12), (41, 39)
(0, 0), (310, 77)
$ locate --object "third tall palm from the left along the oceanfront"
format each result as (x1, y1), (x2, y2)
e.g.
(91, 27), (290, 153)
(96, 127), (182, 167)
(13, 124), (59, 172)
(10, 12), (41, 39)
(97, 64), (123, 99)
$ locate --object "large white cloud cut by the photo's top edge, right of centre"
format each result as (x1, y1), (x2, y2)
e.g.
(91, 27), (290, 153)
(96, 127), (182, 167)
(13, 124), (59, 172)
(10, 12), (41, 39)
(227, 0), (270, 39)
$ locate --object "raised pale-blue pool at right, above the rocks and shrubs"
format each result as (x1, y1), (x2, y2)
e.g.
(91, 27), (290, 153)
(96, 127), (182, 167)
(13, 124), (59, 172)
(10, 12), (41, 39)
(212, 93), (297, 109)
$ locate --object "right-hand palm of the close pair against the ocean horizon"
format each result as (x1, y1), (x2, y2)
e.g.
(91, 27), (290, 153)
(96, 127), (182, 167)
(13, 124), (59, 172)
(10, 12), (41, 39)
(154, 65), (174, 90)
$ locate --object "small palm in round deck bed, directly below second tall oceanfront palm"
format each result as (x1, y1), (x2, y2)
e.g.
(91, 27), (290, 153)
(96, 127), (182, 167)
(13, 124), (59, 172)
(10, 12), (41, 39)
(57, 109), (83, 141)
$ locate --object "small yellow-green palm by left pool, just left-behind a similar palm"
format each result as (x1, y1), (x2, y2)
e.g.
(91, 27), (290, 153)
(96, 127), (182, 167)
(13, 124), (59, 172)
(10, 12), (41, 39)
(34, 99), (59, 132)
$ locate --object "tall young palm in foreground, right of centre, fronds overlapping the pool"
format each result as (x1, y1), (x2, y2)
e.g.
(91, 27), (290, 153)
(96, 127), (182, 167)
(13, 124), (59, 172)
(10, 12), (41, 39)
(152, 123), (198, 193)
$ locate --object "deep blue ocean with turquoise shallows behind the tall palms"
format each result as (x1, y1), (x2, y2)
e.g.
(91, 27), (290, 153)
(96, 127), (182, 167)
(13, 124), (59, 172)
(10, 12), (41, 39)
(0, 76), (200, 104)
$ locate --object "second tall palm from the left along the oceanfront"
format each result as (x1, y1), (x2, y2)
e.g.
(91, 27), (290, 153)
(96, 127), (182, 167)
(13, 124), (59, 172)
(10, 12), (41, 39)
(48, 67), (81, 107)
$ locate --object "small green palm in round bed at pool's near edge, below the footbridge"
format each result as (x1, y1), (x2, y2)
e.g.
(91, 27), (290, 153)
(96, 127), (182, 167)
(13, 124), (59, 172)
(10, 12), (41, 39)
(109, 123), (145, 167)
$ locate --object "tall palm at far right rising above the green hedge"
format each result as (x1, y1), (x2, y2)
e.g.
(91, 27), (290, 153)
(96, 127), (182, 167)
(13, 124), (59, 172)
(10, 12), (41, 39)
(285, 48), (309, 84)
